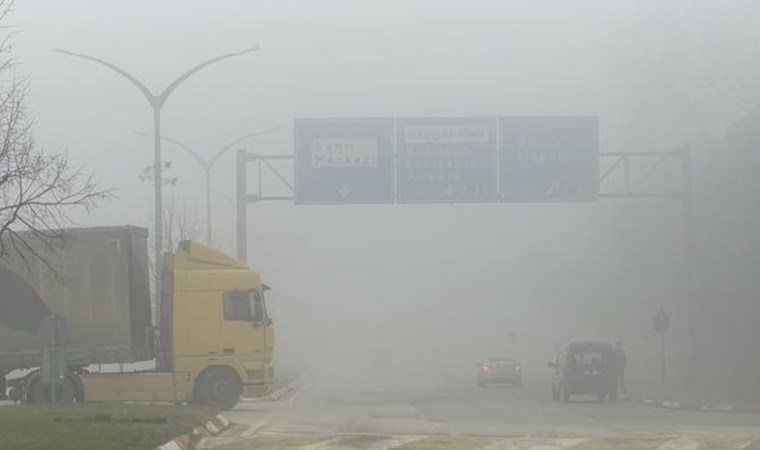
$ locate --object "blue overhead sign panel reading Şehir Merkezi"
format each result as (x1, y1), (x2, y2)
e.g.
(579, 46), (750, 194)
(294, 118), (395, 204)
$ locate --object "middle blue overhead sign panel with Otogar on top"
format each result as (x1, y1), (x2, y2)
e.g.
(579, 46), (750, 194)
(396, 117), (498, 203)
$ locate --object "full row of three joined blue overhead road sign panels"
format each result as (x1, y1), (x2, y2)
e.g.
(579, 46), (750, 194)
(294, 116), (599, 204)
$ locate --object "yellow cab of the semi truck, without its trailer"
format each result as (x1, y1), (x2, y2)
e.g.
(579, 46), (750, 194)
(159, 241), (274, 406)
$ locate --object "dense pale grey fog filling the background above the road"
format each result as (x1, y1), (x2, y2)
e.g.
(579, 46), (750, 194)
(5, 0), (760, 401)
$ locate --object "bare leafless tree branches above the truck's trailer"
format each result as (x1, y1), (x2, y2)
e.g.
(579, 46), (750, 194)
(0, 0), (112, 265)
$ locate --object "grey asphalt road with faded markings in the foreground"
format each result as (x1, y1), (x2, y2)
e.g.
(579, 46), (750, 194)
(201, 383), (760, 450)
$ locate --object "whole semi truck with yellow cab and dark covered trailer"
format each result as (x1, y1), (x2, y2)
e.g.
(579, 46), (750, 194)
(0, 226), (274, 408)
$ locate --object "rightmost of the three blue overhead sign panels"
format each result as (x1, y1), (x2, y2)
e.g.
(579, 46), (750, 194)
(499, 116), (599, 202)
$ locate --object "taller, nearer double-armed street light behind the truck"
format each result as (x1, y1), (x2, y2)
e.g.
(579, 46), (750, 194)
(53, 44), (260, 366)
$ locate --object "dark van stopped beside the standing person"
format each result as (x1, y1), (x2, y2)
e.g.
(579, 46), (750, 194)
(549, 342), (617, 403)
